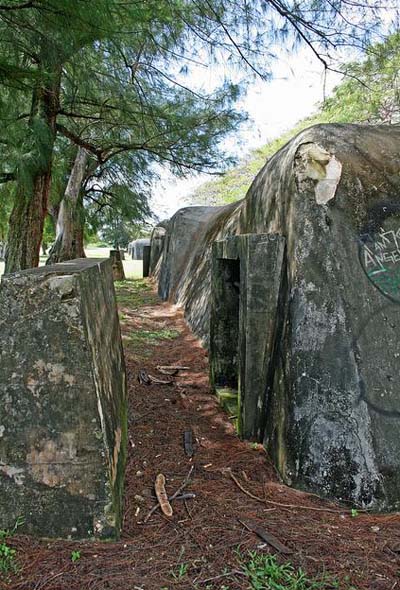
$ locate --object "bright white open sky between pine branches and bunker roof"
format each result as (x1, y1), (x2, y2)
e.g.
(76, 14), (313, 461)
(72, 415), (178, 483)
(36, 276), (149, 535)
(152, 49), (340, 219)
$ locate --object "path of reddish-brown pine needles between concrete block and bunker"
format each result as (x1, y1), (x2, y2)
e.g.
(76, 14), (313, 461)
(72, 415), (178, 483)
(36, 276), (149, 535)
(4, 281), (400, 590)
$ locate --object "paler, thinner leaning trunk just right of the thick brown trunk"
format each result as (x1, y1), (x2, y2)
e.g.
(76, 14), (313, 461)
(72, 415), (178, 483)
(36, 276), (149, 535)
(46, 147), (89, 264)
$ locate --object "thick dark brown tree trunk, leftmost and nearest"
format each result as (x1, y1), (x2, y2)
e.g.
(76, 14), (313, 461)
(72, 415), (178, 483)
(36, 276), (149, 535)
(5, 65), (61, 273)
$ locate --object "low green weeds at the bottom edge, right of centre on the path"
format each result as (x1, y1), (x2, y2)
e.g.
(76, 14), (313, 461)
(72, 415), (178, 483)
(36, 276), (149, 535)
(242, 551), (339, 590)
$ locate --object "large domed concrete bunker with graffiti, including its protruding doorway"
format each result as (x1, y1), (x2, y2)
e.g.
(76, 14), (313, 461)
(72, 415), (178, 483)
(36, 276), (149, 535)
(157, 124), (400, 510)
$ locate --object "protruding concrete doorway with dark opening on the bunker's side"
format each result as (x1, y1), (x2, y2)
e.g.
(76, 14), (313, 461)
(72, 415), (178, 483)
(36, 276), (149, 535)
(210, 234), (285, 442)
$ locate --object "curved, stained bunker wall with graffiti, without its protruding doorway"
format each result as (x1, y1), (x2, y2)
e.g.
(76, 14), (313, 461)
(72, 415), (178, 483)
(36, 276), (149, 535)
(156, 125), (400, 508)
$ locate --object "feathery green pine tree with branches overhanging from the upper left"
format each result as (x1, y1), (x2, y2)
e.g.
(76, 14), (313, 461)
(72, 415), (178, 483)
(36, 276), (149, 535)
(0, 0), (396, 272)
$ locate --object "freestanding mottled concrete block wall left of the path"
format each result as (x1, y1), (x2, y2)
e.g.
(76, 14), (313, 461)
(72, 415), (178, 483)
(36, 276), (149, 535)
(0, 259), (127, 538)
